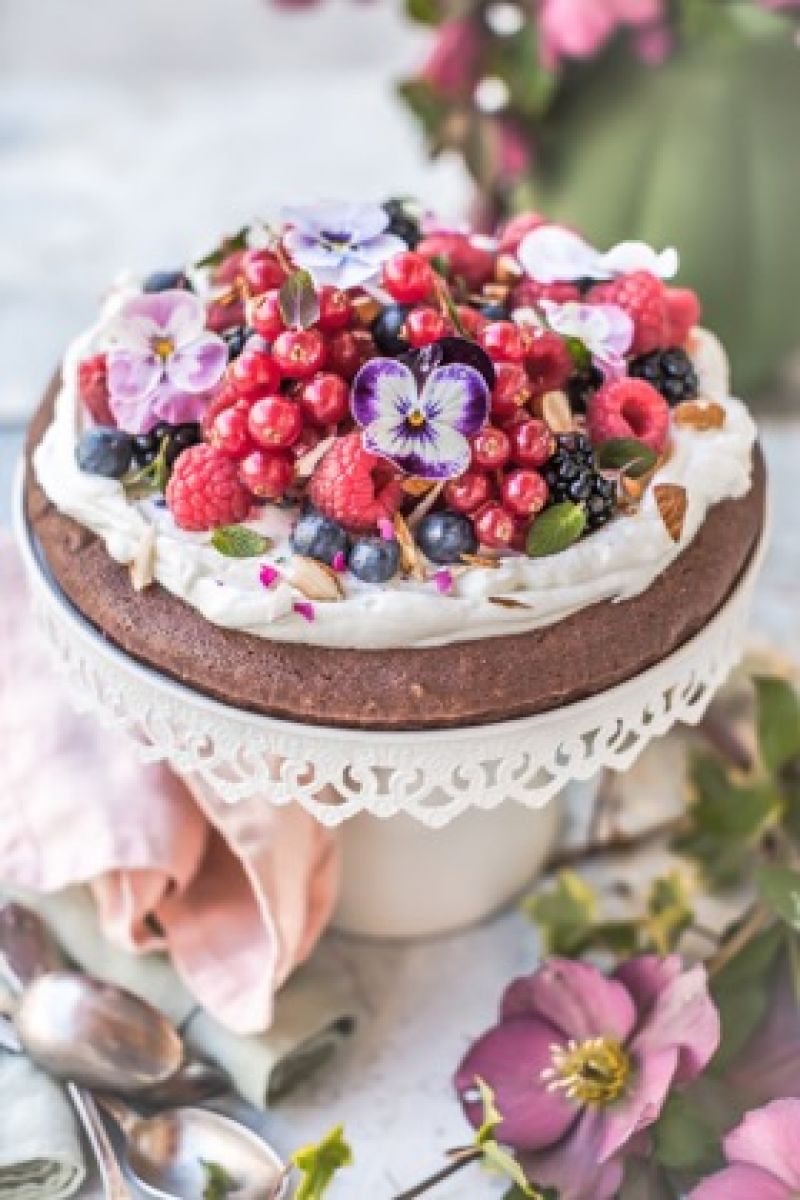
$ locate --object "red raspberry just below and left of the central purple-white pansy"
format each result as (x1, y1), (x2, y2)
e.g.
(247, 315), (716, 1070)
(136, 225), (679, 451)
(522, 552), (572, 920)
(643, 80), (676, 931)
(308, 432), (403, 530)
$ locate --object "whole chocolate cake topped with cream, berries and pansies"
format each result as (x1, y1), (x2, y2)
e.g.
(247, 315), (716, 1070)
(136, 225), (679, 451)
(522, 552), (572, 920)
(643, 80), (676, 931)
(25, 205), (765, 730)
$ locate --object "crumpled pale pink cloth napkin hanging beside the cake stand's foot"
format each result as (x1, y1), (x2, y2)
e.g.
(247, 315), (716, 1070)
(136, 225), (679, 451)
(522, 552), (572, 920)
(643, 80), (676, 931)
(0, 530), (339, 1033)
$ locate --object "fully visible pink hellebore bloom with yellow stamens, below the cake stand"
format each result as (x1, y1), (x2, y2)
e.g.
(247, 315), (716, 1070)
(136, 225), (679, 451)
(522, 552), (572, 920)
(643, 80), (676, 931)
(456, 955), (720, 1200)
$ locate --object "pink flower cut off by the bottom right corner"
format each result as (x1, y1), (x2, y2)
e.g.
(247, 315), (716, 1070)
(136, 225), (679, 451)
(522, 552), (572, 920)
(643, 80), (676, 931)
(690, 1098), (800, 1200)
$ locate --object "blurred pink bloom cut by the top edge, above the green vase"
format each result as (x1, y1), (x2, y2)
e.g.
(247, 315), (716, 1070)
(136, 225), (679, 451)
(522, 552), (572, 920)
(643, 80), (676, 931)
(539, 0), (664, 67)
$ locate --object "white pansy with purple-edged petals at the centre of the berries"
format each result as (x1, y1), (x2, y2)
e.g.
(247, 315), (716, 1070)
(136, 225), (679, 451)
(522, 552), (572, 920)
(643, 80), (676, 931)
(350, 359), (491, 479)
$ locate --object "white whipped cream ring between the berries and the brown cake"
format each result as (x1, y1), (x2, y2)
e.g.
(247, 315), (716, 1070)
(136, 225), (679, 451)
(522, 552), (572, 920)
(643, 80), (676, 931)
(35, 304), (756, 650)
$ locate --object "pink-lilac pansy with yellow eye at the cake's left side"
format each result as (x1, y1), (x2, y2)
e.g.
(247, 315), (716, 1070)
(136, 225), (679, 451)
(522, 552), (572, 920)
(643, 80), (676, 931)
(104, 290), (228, 433)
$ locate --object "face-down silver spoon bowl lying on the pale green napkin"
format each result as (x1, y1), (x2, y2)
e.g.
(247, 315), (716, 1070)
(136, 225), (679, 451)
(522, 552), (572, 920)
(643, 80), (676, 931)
(14, 971), (184, 1094)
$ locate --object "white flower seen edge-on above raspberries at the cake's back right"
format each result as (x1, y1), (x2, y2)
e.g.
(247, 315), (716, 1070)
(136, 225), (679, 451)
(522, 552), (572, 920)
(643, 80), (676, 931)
(517, 224), (679, 283)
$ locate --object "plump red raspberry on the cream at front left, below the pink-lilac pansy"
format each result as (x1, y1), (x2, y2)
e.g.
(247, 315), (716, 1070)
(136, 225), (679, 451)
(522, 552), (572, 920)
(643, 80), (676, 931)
(167, 445), (252, 533)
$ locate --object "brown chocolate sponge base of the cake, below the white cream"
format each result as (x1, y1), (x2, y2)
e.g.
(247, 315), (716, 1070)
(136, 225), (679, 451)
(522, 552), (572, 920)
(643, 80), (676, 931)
(25, 385), (766, 730)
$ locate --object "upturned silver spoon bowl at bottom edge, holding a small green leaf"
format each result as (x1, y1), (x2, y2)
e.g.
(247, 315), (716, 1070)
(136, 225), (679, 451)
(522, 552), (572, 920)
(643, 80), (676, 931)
(97, 1096), (288, 1200)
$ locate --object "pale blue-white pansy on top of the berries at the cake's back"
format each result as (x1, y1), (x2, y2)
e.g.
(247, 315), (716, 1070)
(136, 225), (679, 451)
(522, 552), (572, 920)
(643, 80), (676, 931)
(282, 202), (408, 288)
